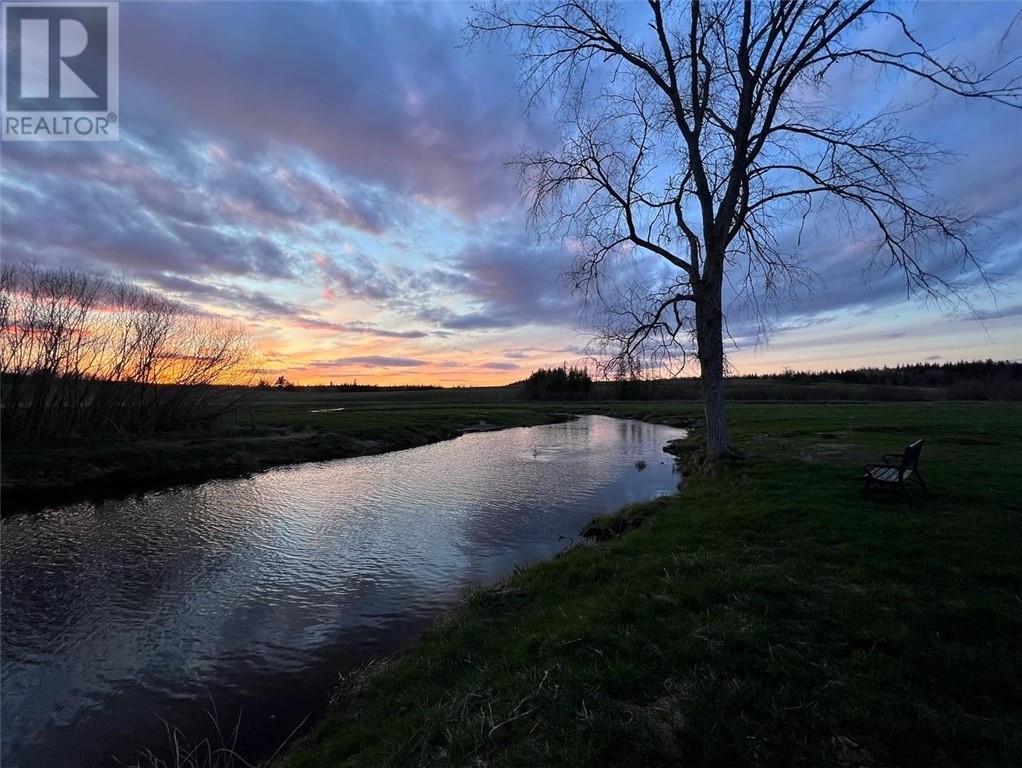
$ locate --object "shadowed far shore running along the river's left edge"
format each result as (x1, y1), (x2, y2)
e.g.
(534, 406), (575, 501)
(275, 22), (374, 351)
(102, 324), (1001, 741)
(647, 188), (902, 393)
(0, 407), (573, 516)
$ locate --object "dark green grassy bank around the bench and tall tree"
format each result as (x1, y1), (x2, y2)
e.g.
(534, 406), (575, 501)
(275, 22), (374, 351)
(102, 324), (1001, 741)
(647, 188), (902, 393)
(284, 404), (1022, 768)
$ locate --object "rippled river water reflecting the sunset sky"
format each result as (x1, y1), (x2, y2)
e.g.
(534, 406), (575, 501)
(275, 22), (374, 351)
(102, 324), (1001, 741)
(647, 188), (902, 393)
(0, 416), (683, 768)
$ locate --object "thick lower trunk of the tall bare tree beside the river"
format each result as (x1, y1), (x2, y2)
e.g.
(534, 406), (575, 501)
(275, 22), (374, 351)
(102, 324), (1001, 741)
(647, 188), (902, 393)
(696, 274), (734, 458)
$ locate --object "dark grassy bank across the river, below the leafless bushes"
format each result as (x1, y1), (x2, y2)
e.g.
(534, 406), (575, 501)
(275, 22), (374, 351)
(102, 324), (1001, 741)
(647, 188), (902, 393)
(0, 392), (567, 514)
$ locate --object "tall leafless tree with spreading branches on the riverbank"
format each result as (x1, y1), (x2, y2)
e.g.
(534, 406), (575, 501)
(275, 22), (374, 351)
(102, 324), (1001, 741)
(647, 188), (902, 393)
(469, 0), (1022, 456)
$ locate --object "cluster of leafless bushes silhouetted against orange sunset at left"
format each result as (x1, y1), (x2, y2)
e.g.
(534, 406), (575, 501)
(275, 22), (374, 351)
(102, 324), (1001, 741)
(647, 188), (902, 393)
(0, 264), (249, 442)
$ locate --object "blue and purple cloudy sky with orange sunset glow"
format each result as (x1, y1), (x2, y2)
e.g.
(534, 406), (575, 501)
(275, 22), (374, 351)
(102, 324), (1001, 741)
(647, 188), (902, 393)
(0, 2), (1022, 386)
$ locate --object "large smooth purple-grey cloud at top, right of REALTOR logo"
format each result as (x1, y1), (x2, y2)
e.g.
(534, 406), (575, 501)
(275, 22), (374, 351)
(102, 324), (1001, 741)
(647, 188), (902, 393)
(121, 3), (552, 216)
